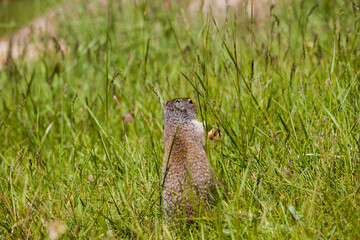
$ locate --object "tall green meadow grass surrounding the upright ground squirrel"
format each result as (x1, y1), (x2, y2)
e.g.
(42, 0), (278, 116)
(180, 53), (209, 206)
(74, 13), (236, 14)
(0, 0), (360, 239)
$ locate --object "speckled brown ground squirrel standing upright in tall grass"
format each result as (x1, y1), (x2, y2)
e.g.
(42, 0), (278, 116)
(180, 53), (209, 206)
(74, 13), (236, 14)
(162, 98), (217, 217)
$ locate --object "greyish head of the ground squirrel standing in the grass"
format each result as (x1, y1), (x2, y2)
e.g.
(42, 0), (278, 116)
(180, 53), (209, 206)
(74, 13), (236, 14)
(164, 98), (197, 124)
